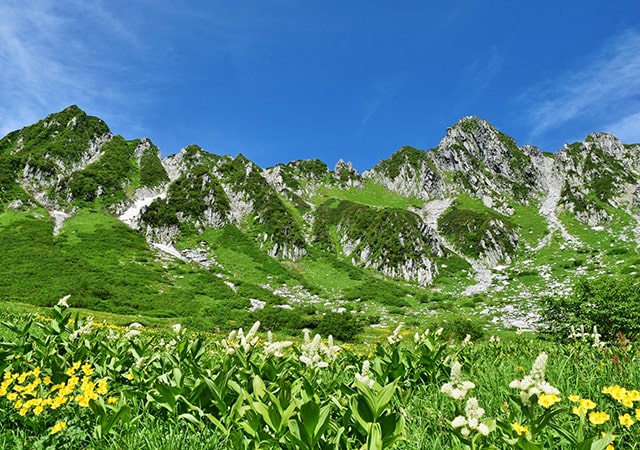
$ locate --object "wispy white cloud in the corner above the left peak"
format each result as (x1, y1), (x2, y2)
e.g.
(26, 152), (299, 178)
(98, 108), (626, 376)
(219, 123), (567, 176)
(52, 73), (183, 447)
(0, 0), (147, 137)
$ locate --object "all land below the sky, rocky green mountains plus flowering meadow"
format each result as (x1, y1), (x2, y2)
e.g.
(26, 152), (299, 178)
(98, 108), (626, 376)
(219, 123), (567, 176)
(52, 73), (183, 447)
(0, 106), (640, 450)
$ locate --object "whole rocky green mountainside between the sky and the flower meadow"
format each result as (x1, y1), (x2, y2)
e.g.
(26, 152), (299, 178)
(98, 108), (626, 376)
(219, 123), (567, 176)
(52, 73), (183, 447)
(0, 106), (640, 331)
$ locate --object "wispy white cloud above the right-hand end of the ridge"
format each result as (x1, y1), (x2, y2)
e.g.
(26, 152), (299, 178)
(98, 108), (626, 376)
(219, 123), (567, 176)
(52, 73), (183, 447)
(521, 30), (640, 138)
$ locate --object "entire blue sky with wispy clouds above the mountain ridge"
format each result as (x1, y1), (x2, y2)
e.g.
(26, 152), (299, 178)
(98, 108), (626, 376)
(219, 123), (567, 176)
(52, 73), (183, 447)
(0, 0), (640, 171)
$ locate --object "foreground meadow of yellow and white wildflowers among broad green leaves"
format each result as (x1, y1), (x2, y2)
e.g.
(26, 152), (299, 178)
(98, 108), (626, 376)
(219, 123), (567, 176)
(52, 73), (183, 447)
(0, 299), (640, 450)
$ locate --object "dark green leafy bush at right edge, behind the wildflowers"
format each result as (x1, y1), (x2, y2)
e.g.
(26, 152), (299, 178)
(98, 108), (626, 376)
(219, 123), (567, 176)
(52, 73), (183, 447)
(544, 275), (640, 341)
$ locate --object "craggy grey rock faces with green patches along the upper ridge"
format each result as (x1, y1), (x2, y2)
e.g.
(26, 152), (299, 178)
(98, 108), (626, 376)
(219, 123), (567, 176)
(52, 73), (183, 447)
(0, 106), (640, 285)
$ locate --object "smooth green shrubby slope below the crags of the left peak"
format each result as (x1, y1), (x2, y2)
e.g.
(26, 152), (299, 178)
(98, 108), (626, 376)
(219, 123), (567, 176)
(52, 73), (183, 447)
(0, 211), (282, 330)
